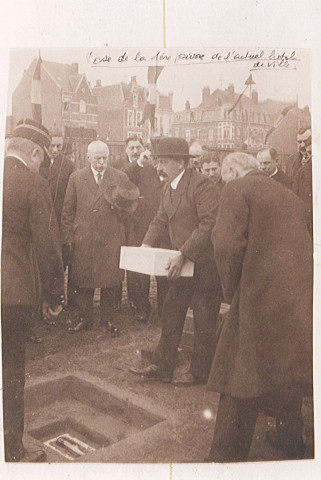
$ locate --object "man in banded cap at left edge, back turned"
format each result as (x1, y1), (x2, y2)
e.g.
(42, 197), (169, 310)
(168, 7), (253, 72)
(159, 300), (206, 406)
(1, 119), (63, 462)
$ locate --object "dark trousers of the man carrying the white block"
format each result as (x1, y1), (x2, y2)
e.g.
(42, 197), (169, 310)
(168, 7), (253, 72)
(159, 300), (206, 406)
(153, 278), (220, 380)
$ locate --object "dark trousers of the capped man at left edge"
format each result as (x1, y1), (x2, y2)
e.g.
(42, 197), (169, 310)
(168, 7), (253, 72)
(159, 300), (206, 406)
(1, 306), (32, 462)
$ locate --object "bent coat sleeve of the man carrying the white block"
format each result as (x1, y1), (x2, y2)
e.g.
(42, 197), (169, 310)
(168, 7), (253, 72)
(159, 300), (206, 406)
(180, 178), (220, 262)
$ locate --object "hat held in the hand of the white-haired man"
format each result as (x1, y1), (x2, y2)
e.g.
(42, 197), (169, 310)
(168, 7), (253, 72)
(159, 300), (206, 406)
(105, 180), (139, 213)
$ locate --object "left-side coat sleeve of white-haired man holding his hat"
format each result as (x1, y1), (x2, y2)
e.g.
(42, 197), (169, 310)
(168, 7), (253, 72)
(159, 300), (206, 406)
(61, 172), (77, 244)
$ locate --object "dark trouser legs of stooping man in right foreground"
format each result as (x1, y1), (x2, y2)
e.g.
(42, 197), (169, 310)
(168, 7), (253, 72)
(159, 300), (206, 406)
(208, 386), (303, 463)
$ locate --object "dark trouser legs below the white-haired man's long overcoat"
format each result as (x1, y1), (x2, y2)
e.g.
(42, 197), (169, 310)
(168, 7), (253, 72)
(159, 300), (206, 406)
(74, 285), (119, 328)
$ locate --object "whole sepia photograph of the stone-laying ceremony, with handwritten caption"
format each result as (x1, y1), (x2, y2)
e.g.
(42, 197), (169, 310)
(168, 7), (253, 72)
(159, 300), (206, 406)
(1, 47), (314, 464)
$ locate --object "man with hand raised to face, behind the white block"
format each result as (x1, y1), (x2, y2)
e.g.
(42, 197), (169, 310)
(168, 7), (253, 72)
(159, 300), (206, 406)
(123, 146), (170, 323)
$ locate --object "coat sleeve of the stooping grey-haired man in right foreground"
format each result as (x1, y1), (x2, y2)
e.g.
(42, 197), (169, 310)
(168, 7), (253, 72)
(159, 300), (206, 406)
(212, 180), (249, 304)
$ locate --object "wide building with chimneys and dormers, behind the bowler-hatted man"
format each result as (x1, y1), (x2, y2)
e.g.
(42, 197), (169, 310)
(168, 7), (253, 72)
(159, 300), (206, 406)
(172, 84), (285, 150)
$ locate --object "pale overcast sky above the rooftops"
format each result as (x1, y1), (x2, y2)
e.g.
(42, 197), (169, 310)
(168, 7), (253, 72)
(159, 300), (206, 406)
(7, 48), (311, 114)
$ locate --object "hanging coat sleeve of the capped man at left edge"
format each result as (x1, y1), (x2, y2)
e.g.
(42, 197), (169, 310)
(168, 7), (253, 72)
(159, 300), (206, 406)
(30, 176), (64, 304)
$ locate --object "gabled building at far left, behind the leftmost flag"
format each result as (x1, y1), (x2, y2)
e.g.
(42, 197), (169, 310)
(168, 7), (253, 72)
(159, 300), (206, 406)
(12, 59), (98, 167)
